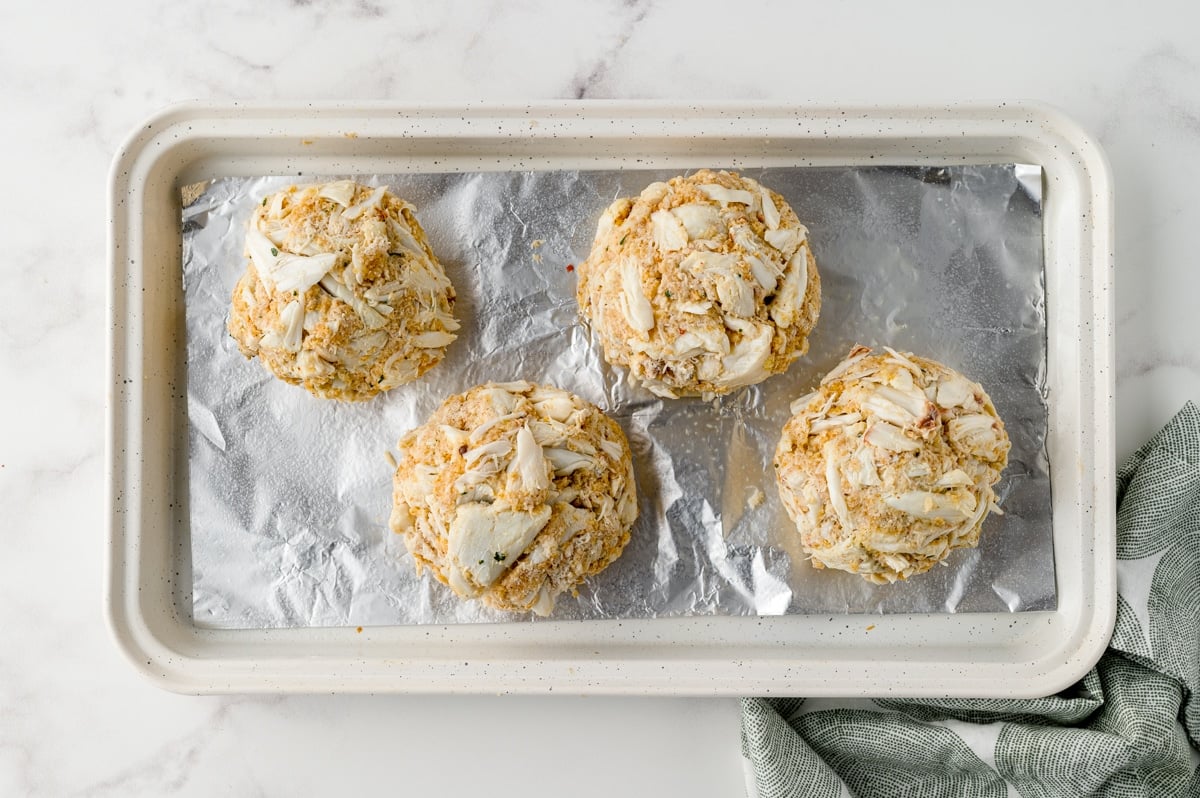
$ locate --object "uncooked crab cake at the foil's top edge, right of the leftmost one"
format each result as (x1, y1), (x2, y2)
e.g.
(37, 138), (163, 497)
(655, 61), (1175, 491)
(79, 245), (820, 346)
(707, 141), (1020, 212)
(577, 169), (821, 398)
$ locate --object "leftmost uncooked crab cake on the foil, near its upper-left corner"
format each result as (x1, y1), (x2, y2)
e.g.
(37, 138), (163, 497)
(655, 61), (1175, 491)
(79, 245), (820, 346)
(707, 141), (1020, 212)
(228, 180), (458, 401)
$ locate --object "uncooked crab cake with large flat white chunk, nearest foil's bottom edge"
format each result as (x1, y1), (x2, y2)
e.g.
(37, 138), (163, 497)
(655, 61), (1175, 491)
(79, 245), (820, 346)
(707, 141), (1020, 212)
(390, 382), (637, 616)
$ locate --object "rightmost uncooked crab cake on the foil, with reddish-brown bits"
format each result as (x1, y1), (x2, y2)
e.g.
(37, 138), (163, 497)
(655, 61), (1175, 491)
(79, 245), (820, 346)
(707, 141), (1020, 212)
(775, 347), (1009, 584)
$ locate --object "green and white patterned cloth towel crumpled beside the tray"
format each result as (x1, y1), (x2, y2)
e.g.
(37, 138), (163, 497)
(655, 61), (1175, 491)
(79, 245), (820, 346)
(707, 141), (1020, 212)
(742, 402), (1200, 798)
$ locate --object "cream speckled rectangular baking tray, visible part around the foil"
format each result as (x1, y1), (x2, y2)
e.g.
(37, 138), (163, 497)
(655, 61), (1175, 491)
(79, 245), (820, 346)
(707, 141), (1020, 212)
(106, 103), (1116, 696)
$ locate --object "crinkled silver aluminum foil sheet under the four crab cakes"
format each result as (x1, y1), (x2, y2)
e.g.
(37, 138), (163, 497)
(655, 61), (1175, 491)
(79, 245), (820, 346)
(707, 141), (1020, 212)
(182, 164), (1056, 629)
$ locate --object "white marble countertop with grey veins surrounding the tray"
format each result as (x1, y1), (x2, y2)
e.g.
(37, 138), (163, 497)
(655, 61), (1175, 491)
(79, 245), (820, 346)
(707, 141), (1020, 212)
(0, 0), (1200, 796)
